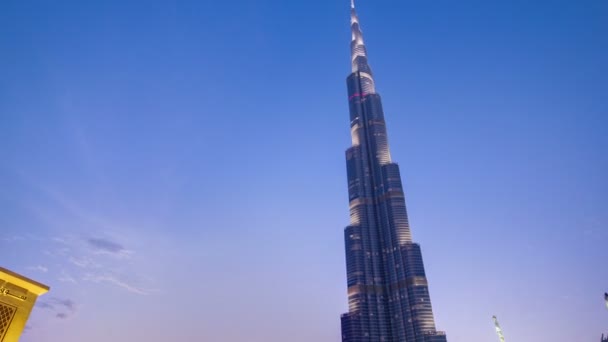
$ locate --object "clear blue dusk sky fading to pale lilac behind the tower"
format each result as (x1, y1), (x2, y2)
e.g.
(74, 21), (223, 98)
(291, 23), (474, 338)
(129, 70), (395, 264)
(0, 0), (608, 342)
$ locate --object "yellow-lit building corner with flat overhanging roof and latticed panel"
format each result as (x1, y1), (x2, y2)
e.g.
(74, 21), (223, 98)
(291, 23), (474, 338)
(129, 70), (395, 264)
(0, 267), (49, 342)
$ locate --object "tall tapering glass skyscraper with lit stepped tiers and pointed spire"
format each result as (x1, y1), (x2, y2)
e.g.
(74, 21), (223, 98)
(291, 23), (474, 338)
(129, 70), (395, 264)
(341, 0), (446, 342)
